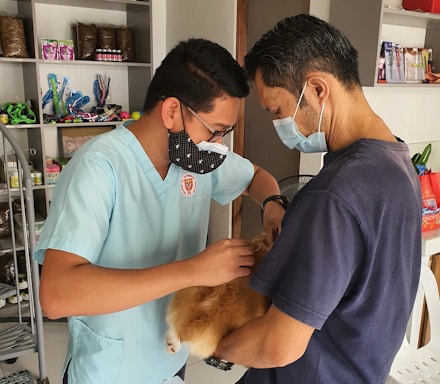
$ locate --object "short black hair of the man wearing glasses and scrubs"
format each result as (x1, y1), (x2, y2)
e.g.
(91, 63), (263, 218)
(144, 38), (249, 112)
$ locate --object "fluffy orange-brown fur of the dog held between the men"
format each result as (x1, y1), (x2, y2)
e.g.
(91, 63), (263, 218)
(166, 236), (270, 358)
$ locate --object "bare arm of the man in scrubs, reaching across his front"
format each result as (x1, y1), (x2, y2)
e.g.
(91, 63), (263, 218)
(40, 239), (255, 319)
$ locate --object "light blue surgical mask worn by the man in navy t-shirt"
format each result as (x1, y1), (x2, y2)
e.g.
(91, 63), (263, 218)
(273, 83), (327, 153)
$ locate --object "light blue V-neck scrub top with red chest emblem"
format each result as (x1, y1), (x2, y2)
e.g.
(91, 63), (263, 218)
(34, 125), (254, 384)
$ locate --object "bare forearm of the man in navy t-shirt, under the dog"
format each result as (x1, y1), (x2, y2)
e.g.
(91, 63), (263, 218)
(214, 305), (315, 368)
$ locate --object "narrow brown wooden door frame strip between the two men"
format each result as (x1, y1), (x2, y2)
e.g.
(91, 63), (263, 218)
(231, 0), (248, 238)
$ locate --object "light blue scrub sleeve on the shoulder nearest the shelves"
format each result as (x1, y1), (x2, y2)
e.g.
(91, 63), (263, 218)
(34, 153), (115, 263)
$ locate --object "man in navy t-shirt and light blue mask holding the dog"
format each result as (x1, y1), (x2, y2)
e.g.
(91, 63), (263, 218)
(214, 15), (421, 384)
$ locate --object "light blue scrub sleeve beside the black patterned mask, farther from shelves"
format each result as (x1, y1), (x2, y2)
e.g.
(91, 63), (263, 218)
(212, 152), (254, 205)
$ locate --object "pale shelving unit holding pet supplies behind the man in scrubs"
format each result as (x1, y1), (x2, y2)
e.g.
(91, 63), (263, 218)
(0, 0), (152, 217)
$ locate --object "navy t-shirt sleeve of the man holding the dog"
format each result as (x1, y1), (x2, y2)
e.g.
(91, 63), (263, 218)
(251, 191), (363, 329)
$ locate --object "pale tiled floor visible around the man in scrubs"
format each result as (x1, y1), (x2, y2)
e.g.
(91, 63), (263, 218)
(0, 322), (245, 384)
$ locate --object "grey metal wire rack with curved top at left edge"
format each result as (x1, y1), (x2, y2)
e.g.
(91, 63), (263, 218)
(0, 123), (49, 384)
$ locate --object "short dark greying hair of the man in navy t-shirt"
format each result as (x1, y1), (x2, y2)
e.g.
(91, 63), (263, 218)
(244, 14), (360, 96)
